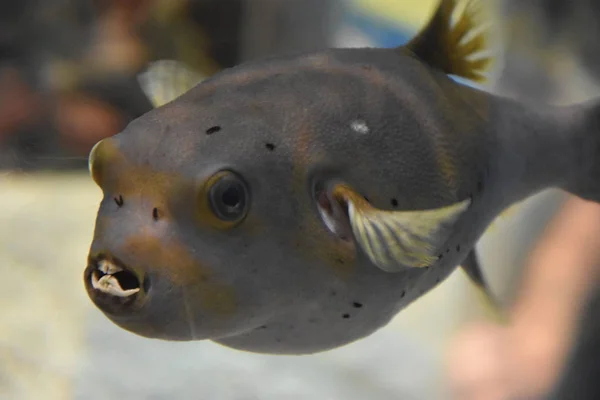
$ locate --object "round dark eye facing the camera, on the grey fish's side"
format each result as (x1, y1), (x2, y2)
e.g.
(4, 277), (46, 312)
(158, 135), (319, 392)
(208, 171), (249, 222)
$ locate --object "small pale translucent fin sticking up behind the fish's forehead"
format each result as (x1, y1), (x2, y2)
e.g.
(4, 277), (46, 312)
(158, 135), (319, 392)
(138, 60), (204, 108)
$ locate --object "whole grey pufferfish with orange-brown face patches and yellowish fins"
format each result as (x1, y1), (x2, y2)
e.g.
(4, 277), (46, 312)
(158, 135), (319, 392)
(84, 0), (600, 354)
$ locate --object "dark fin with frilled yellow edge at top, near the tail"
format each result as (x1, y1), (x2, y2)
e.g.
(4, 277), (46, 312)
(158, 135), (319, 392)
(403, 0), (492, 82)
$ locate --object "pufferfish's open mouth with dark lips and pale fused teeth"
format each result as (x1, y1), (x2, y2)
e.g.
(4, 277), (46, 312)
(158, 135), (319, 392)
(84, 254), (150, 316)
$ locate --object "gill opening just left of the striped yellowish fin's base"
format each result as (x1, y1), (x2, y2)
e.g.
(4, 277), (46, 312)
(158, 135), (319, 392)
(313, 182), (353, 242)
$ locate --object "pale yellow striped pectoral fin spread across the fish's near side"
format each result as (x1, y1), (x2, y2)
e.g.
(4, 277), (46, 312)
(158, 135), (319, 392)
(334, 185), (471, 272)
